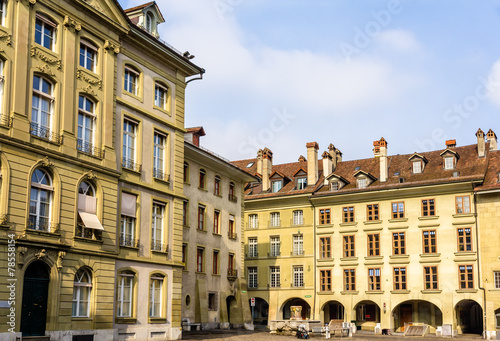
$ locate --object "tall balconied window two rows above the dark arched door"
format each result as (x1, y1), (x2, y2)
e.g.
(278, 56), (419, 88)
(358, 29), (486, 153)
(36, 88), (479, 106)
(31, 75), (54, 139)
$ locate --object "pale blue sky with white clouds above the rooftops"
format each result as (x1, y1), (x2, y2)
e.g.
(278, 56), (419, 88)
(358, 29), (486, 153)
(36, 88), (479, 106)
(120, 0), (500, 163)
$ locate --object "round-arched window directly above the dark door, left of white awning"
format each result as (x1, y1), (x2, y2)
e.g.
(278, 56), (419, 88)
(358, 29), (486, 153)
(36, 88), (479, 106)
(29, 168), (54, 232)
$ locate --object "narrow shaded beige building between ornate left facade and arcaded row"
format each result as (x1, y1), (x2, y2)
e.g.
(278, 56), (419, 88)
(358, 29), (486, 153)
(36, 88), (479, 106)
(182, 127), (257, 330)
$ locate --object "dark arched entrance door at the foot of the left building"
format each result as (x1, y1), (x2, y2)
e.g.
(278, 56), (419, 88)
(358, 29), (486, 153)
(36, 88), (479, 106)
(21, 261), (49, 336)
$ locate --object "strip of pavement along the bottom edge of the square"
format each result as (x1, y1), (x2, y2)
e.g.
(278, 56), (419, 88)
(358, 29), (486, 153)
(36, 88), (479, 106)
(183, 330), (482, 341)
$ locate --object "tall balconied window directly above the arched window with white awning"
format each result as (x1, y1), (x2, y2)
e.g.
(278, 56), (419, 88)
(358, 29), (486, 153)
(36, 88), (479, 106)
(76, 95), (96, 155)
